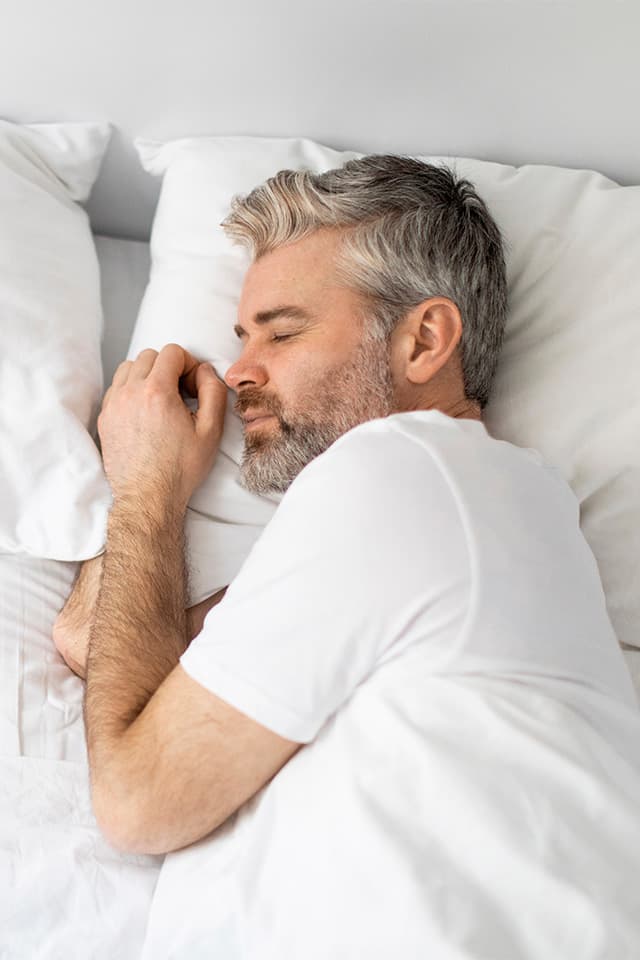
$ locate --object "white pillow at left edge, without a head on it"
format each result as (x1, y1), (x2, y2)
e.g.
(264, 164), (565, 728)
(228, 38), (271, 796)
(0, 120), (111, 560)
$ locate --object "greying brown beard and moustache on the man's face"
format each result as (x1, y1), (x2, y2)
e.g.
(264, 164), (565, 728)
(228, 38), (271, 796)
(239, 339), (395, 494)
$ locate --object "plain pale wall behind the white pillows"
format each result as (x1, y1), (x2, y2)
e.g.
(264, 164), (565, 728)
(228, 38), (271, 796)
(0, 0), (640, 239)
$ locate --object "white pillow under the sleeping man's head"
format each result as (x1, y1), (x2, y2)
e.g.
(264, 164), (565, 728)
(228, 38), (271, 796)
(129, 137), (640, 646)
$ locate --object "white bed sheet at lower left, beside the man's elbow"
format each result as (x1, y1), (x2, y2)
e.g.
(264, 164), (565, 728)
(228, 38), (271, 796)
(0, 555), (164, 960)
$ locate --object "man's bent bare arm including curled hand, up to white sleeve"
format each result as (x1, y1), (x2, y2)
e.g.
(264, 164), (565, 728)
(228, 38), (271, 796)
(75, 344), (300, 853)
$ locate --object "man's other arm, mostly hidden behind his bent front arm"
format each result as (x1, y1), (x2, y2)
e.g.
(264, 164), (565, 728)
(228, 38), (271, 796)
(53, 553), (227, 680)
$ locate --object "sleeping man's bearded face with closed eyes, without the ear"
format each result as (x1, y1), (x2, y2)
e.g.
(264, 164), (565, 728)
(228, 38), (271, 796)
(225, 229), (395, 494)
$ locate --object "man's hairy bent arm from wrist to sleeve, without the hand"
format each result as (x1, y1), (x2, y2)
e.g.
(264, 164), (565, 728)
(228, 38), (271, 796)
(84, 497), (299, 853)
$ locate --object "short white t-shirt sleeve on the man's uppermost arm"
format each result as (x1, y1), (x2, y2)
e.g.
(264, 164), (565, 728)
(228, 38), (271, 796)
(180, 425), (466, 743)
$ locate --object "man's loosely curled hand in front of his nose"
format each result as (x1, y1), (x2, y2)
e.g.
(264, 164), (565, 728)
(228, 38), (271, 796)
(97, 343), (227, 510)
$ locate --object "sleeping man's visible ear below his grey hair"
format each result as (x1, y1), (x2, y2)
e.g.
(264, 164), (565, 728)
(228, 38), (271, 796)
(394, 297), (462, 383)
